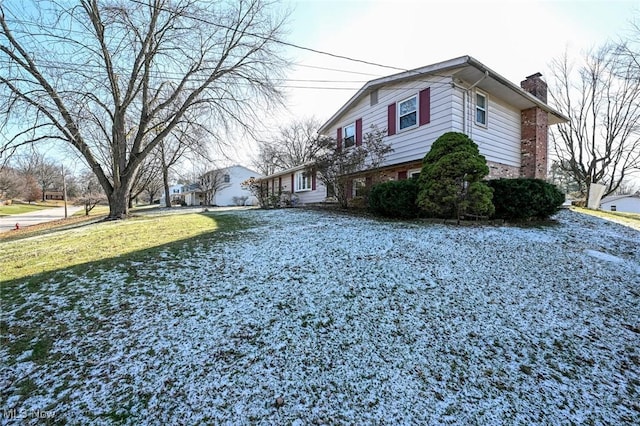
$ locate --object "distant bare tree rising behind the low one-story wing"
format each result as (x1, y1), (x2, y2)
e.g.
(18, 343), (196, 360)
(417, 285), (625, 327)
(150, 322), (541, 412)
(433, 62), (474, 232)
(253, 117), (321, 176)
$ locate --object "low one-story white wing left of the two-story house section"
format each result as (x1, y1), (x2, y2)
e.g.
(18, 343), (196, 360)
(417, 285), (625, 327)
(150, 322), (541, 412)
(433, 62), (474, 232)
(261, 164), (331, 205)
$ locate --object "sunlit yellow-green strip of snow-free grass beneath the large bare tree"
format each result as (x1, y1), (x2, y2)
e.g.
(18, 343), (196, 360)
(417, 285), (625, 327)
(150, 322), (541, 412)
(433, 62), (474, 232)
(0, 213), (252, 282)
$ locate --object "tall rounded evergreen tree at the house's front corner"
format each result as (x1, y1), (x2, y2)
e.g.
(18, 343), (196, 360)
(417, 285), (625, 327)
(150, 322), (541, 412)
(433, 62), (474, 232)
(418, 132), (494, 219)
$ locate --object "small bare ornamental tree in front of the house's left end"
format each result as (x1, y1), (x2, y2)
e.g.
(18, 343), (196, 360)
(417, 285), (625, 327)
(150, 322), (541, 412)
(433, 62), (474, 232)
(312, 126), (393, 208)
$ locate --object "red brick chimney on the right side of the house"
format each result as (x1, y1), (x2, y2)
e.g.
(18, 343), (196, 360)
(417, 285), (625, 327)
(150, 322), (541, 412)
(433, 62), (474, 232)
(520, 73), (549, 179)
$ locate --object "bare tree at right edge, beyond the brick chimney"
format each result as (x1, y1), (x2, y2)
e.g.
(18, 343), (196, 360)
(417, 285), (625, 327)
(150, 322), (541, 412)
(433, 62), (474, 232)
(550, 45), (640, 195)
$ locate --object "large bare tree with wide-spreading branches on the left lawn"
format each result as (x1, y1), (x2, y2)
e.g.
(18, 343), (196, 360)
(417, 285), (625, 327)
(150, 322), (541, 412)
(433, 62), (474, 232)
(0, 0), (285, 219)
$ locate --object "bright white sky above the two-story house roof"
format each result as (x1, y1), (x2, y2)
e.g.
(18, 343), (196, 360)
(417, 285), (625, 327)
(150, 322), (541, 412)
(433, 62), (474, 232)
(228, 0), (640, 168)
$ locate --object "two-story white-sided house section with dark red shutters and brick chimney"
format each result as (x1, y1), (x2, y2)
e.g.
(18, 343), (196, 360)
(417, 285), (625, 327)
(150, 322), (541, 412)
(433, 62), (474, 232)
(319, 56), (568, 196)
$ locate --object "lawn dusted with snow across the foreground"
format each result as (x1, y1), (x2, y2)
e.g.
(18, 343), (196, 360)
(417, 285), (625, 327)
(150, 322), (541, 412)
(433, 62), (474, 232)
(0, 210), (640, 425)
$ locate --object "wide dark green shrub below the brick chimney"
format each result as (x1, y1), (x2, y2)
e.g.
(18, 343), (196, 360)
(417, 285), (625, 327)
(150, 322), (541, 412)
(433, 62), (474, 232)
(488, 178), (564, 219)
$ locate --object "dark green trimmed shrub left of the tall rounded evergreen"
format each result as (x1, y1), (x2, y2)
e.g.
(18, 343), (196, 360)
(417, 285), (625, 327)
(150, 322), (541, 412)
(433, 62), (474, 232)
(369, 179), (420, 218)
